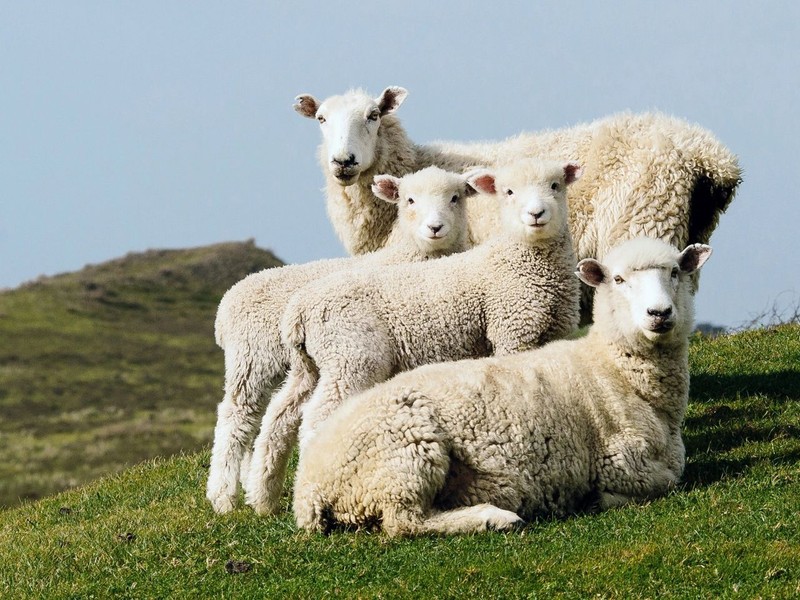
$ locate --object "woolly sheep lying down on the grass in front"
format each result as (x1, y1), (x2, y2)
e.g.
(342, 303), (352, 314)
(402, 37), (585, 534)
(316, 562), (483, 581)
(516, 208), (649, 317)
(294, 238), (711, 535)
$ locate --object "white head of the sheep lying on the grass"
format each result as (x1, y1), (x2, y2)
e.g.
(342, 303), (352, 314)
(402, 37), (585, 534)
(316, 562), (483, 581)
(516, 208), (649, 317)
(577, 238), (711, 344)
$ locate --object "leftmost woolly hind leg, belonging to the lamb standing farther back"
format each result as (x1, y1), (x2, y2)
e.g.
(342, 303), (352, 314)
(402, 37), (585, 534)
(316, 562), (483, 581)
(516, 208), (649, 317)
(206, 352), (283, 513)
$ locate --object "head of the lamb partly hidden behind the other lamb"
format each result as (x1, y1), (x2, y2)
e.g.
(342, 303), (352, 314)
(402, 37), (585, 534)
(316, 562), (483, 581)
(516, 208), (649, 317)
(372, 167), (476, 252)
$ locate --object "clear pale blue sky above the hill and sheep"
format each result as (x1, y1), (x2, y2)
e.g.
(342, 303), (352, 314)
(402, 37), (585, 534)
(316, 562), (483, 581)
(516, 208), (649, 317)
(0, 0), (800, 326)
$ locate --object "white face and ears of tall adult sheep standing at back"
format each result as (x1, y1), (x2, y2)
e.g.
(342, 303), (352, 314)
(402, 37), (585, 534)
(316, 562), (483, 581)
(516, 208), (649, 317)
(294, 87), (408, 186)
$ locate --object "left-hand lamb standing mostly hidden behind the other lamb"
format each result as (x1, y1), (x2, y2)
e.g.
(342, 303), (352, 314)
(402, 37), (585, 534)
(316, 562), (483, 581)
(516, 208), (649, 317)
(206, 167), (475, 513)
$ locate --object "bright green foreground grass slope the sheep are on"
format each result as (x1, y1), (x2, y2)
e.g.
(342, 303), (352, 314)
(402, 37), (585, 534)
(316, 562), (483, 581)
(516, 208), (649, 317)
(0, 325), (800, 598)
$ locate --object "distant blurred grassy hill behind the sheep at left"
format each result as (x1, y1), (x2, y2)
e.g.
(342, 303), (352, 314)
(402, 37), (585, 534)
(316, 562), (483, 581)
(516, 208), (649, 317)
(0, 242), (281, 505)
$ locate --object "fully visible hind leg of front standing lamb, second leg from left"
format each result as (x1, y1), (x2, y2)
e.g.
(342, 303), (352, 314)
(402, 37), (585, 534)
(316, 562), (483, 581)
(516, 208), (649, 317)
(245, 367), (316, 515)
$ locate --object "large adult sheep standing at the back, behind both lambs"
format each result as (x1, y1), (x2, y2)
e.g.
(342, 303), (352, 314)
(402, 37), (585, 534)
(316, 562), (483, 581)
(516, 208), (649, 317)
(294, 86), (742, 323)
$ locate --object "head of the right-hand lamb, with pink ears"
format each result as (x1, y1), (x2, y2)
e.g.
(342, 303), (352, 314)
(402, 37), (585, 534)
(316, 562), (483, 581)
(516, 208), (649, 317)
(468, 160), (582, 243)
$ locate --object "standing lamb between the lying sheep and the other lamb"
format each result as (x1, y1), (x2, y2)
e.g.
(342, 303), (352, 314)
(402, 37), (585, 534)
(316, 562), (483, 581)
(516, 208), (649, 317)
(246, 159), (581, 514)
